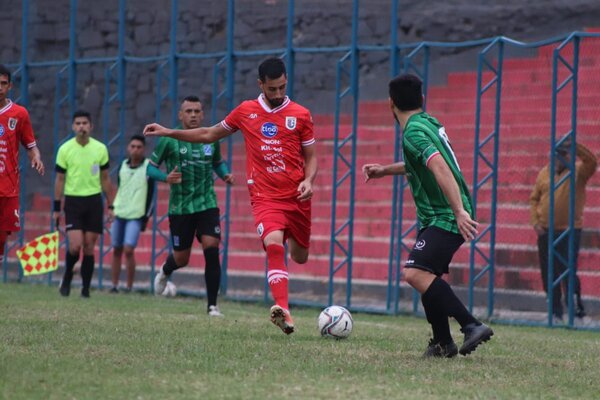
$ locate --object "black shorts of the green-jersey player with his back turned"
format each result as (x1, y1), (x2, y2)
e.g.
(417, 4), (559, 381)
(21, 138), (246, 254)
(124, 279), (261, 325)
(404, 226), (465, 276)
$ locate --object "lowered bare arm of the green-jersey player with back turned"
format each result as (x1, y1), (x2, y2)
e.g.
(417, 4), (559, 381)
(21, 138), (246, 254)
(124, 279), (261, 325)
(427, 156), (479, 240)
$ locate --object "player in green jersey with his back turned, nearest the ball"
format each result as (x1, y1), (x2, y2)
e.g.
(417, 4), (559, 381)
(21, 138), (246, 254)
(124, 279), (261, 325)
(363, 74), (494, 357)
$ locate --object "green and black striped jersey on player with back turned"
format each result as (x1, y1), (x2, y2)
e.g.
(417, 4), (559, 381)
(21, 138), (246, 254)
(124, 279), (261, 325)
(402, 112), (474, 233)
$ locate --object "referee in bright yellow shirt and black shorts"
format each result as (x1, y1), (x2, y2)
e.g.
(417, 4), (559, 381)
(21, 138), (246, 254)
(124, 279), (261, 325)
(53, 111), (113, 298)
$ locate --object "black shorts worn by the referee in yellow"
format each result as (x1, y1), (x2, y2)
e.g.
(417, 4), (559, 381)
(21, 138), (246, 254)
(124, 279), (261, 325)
(65, 193), (104, 234)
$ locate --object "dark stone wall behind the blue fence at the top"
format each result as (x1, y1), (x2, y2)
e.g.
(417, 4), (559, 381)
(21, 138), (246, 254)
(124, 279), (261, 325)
(0, 0), (600, 196)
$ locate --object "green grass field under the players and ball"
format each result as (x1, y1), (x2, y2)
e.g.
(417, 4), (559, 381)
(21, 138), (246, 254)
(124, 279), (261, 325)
(0, 284), (600, 400)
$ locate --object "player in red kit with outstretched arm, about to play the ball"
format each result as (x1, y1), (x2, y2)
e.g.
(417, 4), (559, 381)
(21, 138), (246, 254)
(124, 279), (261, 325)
(144, 58), (317, 335)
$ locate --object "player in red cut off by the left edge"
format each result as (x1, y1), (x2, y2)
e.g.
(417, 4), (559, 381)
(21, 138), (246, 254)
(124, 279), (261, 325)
(0, 65), (44, 263)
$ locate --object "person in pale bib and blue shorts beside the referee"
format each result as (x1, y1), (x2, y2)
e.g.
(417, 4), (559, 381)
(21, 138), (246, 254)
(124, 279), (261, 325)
(110, 135), (154, 293)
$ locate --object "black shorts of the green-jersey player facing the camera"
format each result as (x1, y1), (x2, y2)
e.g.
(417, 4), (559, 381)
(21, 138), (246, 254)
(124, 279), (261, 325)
(169, 208), (221, 250)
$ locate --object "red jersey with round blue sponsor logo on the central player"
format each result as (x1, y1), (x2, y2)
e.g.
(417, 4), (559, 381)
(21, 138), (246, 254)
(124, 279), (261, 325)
(221, 94), (315, 199)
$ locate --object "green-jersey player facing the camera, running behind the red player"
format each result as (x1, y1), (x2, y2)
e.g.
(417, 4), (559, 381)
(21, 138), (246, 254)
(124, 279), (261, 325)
(148, 96), (234, 316)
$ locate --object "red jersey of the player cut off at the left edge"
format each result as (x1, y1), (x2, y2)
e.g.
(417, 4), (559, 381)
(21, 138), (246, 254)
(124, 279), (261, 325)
(0, 100), (35, 197)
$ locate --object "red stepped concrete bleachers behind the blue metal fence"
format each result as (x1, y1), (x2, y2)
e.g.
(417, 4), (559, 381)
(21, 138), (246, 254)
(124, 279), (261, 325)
(17, 35), (600, 304)
